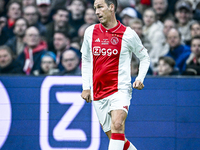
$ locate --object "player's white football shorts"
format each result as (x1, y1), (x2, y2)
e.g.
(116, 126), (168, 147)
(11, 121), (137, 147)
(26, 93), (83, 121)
(93, 90), (132, 132)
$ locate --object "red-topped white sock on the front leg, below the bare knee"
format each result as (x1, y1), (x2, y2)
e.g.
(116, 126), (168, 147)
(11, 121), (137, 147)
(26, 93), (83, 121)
(108, 133), (125, 150)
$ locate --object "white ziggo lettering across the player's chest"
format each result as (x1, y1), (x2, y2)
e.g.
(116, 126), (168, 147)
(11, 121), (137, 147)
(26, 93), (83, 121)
(93, 46), (118, 56)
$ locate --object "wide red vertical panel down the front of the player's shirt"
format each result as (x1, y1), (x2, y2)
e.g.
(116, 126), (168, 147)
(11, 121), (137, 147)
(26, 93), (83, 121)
(92, 22), (126, 100)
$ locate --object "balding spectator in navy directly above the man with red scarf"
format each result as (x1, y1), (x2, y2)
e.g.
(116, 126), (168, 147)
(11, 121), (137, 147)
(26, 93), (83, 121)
(24, 6), (46, 36)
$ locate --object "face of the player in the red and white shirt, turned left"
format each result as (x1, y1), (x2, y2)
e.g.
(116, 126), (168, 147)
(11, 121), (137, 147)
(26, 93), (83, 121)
(94, 0), (111, 24)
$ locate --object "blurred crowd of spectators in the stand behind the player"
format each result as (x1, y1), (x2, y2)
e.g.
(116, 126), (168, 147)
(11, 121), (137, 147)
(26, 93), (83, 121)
(0, 0), (200, 76)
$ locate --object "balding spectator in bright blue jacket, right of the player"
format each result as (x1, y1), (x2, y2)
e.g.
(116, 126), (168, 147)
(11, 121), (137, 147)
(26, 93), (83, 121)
(166, 28), (191, 73)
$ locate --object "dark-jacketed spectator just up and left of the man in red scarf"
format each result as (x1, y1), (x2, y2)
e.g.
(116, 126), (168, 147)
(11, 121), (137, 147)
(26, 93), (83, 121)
(6, 18), (28, 56)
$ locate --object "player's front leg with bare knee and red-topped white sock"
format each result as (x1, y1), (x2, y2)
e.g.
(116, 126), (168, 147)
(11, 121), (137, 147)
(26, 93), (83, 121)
(108, 109), (127, 150)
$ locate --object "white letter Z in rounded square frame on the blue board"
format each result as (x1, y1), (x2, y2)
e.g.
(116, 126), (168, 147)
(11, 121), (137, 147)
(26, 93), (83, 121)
(40, 76), (100, 150)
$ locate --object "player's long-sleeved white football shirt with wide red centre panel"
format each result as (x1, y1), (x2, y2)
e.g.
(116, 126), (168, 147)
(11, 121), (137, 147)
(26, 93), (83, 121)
(81, 21), (150, 100)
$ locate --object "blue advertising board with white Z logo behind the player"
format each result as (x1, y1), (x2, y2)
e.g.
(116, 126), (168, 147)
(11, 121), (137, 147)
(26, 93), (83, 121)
(0, 76), (200, 150)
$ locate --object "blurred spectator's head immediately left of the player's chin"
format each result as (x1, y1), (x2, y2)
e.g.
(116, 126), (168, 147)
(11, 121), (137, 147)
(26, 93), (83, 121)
(84, 7), (98, 25)
